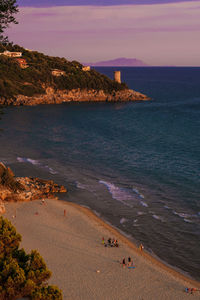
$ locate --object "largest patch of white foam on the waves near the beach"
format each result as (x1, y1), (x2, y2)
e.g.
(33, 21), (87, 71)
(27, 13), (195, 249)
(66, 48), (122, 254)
(99, 180), (133, 207)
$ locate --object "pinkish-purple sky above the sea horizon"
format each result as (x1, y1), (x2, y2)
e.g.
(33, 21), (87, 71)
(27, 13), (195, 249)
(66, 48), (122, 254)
(7, 0), (200, 66)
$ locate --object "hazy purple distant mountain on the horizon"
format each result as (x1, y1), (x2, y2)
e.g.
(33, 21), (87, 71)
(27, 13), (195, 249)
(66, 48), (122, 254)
(84, 57), (148, 67)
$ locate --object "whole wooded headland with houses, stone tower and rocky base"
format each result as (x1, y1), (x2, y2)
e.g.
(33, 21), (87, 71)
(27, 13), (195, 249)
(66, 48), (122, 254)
(0, 44), (149, 106)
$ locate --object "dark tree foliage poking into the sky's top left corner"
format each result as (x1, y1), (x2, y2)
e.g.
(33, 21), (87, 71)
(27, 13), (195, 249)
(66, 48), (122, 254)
(0, 0), (18, 44)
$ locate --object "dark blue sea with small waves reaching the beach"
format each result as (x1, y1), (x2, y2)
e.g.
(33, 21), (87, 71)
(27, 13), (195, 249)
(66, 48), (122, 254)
(0, 67), (200, 280)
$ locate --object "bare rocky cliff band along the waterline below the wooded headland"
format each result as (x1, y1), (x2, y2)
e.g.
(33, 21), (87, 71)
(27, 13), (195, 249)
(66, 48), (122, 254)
(0, 87), (150, 106)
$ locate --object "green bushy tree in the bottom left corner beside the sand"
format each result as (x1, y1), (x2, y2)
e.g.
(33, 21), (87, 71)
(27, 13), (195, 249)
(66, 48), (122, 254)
(0, 217), (62, 300)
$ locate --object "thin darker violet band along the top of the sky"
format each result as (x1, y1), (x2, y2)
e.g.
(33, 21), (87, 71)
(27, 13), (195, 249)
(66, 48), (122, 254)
(18, 0), (198, 7)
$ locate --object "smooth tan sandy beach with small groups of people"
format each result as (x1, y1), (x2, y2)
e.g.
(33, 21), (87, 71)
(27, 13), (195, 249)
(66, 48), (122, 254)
(5, 200), (200, 300)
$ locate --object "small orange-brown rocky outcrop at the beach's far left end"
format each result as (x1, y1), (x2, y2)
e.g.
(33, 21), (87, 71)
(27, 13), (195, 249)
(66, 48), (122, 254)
(0, 163), (67, 214)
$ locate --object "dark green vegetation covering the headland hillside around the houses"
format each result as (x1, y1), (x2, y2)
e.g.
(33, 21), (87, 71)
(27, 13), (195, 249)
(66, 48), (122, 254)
(0, 44), (127, 98)
